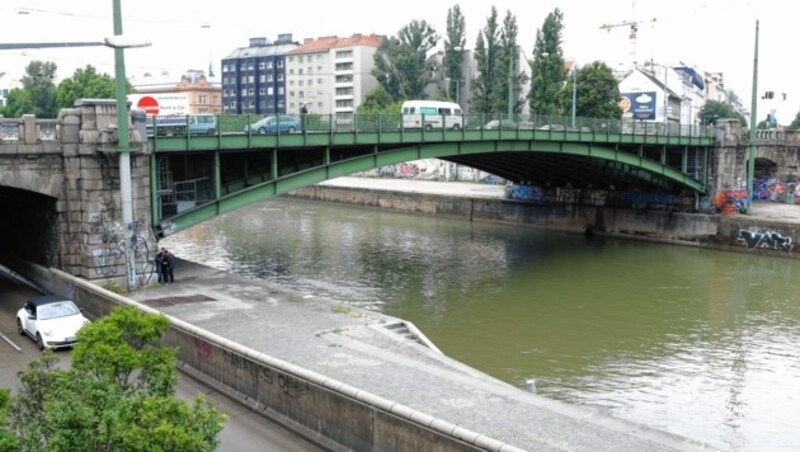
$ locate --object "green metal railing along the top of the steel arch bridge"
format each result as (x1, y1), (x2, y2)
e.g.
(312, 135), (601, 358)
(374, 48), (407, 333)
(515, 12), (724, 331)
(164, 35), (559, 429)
(147, 113), (713, 137)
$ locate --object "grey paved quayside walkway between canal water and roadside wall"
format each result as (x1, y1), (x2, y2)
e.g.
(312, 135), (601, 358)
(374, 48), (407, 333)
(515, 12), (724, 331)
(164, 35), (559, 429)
(129, 260), (709, 451)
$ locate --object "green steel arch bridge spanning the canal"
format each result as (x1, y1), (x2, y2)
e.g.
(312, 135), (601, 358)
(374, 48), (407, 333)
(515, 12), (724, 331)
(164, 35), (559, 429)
(147, 115), (714, 237)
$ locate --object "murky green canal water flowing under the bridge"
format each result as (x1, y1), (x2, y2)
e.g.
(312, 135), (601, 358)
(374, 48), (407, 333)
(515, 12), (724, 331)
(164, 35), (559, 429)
(162, 198), (800, 451)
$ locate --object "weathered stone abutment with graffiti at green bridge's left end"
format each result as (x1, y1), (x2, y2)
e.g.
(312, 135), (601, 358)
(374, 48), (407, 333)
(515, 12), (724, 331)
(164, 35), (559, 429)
(0, 99), (155, 285)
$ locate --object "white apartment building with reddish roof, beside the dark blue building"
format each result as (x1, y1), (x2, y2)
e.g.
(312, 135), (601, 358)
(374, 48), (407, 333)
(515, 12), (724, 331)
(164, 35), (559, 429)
(286, 34), (382, 119)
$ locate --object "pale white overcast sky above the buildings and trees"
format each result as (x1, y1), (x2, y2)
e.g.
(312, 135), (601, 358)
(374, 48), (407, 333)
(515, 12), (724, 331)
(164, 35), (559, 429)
(0, 0), (800, 123)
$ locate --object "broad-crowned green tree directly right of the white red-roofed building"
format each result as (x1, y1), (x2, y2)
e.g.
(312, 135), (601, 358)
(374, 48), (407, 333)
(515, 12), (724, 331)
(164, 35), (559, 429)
(372, 20), (439, 101)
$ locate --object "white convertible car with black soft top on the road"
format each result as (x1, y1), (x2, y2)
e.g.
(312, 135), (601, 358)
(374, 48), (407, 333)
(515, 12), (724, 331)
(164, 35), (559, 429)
(17, 295), (89, 350)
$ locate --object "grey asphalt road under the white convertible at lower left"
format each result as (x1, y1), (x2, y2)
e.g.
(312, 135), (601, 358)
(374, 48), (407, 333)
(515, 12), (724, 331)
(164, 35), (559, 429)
(0, 274), (321, 452)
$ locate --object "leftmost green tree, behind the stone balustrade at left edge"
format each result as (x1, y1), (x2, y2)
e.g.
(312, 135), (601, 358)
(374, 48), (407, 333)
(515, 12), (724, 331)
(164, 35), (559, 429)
(3, 60), (58, 118)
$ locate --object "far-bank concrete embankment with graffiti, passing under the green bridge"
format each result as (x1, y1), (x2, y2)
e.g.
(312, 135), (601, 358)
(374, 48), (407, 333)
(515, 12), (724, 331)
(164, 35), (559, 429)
(288, 177), (800, 257)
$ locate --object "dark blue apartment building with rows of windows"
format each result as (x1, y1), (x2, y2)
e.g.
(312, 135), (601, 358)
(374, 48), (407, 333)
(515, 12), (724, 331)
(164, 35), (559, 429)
(221, 33), (300, 115)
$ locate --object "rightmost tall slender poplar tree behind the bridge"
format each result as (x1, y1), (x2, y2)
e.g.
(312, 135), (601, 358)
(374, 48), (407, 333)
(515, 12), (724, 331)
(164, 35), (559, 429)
(529, 8), (567, 115)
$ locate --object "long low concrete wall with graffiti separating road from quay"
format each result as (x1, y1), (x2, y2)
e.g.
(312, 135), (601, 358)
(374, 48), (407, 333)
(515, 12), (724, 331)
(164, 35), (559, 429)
(32, 264), (521, 452)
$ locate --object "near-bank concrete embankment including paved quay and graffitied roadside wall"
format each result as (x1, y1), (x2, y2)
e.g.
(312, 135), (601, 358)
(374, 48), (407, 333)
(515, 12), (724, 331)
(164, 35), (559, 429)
(7, 252), (709, 452)
